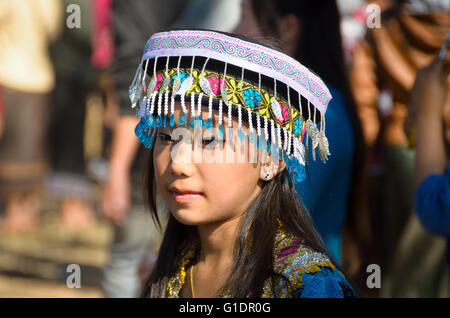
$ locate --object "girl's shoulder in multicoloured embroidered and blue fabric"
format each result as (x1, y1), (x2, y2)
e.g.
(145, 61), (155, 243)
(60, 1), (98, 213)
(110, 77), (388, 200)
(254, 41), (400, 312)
(265, 231), (355, 298)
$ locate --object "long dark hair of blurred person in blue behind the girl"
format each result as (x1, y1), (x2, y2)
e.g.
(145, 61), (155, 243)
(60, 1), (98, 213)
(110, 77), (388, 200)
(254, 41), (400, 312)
(251, 0), (373, 294)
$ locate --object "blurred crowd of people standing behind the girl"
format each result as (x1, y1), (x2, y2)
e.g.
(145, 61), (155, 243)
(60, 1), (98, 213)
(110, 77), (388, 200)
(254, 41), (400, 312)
(0, 0), (450, 297)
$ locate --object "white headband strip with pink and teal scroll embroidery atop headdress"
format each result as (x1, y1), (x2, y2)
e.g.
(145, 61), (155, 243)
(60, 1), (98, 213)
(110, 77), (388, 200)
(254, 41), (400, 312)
(143, 31), (331, 113)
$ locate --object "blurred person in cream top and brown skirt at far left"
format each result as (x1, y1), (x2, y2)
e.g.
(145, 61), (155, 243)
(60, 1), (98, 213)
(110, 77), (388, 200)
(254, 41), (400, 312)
(0, 0), (63, 231)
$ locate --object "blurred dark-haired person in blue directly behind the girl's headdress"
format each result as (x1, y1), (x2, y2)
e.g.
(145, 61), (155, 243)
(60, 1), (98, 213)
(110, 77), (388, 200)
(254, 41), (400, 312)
(234, 0), (370, 296)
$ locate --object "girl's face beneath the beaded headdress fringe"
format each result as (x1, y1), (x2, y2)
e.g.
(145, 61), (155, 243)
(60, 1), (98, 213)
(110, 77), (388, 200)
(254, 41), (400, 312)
(153, 103), (278, 225)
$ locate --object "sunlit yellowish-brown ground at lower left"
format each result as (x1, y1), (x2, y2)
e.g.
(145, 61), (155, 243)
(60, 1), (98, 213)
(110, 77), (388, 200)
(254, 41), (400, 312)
(0, 211), (112, 298)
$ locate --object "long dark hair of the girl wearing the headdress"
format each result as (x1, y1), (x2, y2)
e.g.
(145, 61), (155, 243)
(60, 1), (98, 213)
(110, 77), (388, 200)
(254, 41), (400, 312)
(142, 144), (340, 297)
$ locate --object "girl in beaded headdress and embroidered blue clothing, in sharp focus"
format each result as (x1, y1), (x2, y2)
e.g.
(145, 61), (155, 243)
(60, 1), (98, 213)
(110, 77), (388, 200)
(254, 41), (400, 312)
(130, 30), (354, 297)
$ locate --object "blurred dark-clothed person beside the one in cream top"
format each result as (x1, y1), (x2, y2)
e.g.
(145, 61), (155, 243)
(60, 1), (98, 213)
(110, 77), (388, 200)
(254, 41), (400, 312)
(46, 0), (97, 229)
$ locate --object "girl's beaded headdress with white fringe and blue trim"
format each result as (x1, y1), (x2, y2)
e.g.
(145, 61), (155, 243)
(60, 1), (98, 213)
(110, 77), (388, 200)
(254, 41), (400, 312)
(129, 30), (332, 183)
